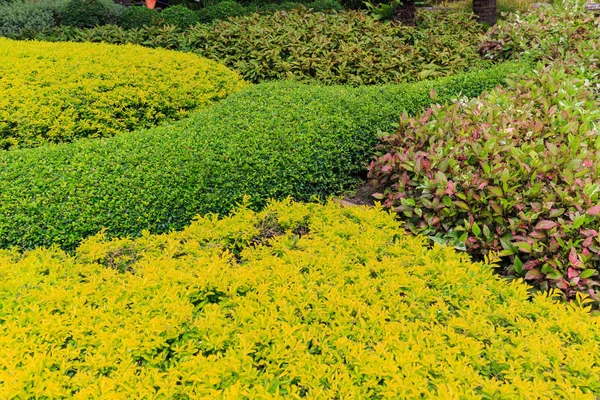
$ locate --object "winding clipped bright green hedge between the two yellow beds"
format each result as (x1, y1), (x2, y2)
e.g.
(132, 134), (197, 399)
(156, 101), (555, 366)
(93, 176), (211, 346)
(0, 64), (524, 249)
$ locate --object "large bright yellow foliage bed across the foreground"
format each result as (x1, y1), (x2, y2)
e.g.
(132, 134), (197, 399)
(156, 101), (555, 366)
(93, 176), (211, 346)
(0, 202), (600, 399)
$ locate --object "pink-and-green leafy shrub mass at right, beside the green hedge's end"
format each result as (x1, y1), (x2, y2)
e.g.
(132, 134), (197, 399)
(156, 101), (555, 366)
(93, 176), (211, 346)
(369, 63), (600, 300)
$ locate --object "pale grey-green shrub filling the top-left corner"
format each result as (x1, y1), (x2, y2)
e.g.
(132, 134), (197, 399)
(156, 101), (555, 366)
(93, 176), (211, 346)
(0, 2), (54, 36)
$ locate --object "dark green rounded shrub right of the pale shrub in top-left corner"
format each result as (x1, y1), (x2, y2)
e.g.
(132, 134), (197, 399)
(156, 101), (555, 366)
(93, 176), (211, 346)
(59, 0), (123, 28)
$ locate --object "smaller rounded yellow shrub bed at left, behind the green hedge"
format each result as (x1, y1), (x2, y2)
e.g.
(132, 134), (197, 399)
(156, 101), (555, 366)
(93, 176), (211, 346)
(0, 38), (241, 149)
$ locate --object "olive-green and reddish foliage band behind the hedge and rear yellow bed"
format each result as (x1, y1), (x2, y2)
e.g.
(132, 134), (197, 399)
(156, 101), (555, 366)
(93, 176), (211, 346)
(19, 8), (489, 85)
